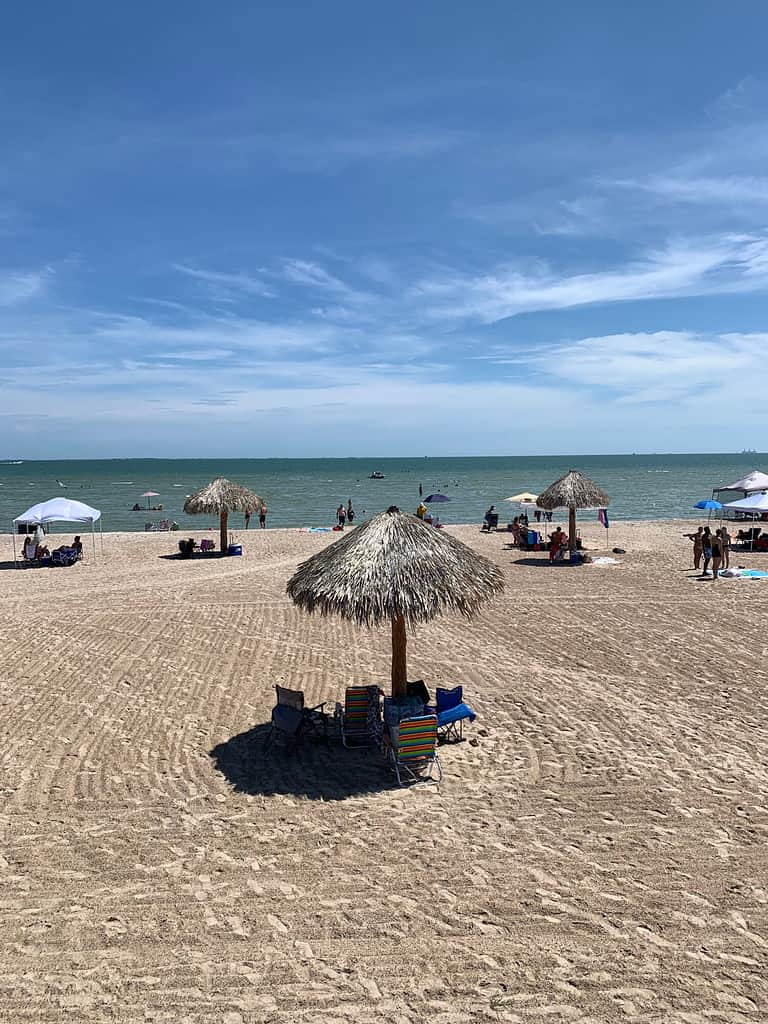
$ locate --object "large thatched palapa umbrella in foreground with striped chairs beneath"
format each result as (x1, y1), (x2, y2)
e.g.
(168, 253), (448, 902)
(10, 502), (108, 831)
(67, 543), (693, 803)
(286, 506), (504, 696)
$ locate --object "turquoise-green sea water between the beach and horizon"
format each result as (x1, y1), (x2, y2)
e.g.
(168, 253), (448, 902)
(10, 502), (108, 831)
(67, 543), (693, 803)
(0, 453), (768, 532)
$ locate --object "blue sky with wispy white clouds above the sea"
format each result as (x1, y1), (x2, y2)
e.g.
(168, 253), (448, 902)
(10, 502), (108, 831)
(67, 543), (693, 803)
(0, 0), (768, 458)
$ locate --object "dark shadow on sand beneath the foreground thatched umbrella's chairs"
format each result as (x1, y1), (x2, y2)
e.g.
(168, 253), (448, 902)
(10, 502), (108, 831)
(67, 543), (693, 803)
(210, 722), (395, 800)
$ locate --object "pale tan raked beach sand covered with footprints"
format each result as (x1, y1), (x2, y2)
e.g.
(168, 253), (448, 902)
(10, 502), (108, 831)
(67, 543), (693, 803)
(0, 523), (768, 1024)
